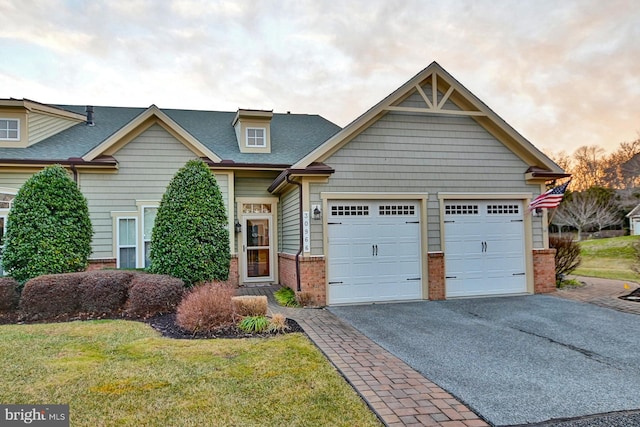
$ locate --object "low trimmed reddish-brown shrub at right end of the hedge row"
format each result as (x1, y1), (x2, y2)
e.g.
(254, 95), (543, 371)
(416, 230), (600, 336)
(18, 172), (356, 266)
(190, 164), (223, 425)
(127, 274), (184, 318)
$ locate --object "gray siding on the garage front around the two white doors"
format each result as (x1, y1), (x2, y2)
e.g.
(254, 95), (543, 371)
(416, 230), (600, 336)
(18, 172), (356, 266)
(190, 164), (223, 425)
(311, 87), (543, 254)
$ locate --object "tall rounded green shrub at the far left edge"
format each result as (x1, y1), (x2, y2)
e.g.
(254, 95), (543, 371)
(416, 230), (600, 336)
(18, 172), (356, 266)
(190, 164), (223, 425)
(2, 165), (93, 283)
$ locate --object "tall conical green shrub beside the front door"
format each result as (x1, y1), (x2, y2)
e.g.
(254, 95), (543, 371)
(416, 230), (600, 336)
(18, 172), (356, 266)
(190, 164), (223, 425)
(150, 160), (230, 287)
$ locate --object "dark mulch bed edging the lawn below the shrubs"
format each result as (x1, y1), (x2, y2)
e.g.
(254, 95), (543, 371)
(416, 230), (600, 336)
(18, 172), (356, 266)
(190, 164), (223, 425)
(0, 311), (304, 339)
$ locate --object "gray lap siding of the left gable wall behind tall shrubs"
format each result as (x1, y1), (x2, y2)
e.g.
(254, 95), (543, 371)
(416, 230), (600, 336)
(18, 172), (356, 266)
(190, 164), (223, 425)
(80, 125), (229, 258)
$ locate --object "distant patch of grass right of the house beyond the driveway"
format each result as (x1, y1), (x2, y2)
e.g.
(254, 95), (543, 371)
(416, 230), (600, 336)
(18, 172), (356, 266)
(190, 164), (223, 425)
(573, 236), (640, 282)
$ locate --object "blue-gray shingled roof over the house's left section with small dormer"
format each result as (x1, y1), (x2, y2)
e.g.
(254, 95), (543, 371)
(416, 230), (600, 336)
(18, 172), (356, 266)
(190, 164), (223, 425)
(0, 105), (340, 166)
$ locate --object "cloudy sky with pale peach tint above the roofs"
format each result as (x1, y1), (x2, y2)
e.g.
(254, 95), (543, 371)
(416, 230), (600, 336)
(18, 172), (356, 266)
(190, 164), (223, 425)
(0, 0), (640, 153)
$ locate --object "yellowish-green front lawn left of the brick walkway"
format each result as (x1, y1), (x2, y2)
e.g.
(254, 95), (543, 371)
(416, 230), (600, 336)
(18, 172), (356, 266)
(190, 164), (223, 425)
(0, 320), (380, 426)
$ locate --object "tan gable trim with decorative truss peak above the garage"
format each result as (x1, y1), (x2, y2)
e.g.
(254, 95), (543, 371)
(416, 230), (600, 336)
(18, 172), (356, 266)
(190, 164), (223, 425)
(292, 62), (568, 179)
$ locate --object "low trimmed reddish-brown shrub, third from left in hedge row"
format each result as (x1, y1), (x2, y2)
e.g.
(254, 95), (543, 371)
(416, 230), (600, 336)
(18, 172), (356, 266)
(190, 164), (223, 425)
(78, 270), (136, 314)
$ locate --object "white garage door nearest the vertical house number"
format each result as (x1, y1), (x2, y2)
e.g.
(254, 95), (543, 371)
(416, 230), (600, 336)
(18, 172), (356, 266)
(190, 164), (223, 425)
(327, 200), (422, 304)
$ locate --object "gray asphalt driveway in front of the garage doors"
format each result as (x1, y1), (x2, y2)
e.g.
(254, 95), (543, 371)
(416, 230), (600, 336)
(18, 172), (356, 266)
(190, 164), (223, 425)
(330, 295), (640, 425)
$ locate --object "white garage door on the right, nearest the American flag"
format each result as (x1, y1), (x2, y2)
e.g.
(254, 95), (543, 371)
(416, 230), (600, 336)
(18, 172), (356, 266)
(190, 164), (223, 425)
(444, 200), (527, 298)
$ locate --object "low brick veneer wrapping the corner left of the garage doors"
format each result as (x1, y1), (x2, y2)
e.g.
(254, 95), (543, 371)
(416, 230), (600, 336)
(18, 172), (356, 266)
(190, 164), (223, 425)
(278, 253), (327, 306)
